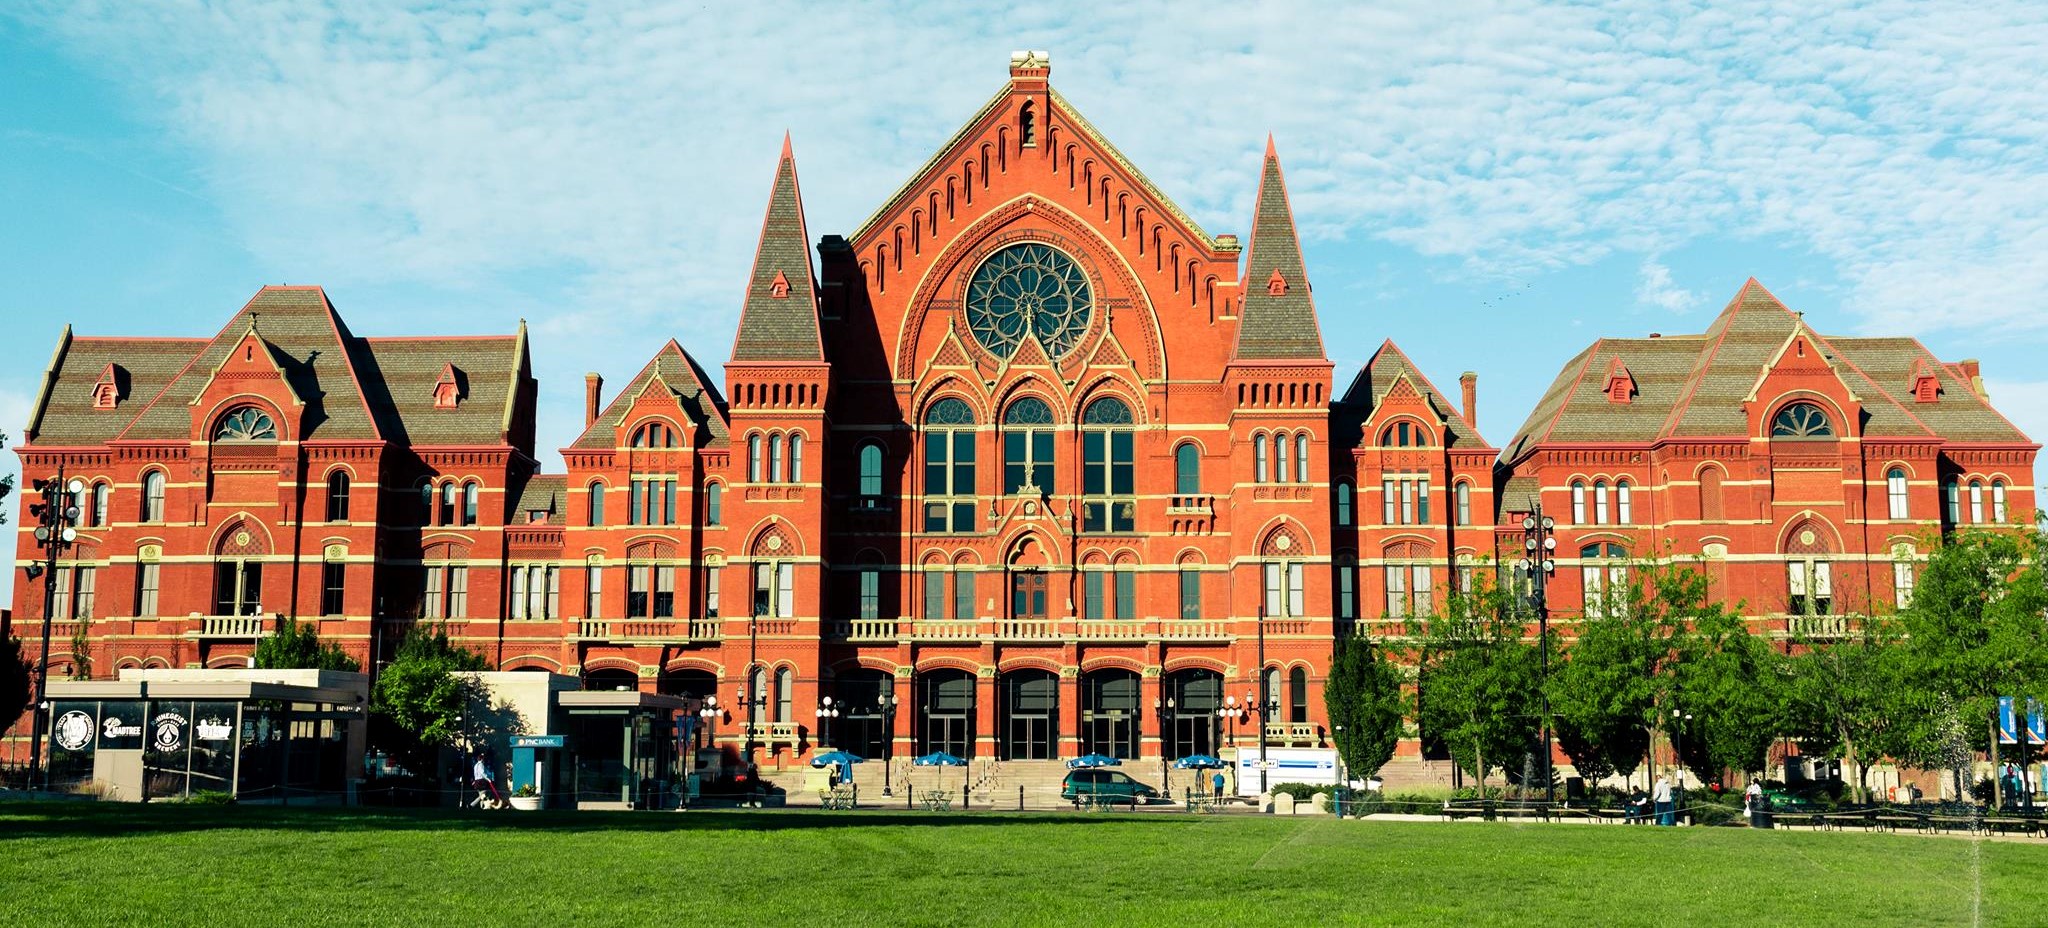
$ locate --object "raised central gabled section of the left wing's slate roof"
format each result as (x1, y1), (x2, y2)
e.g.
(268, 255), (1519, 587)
(121, 287), (381, 440)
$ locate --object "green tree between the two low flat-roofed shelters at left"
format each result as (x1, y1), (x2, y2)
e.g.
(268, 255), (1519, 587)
(371, 627), (489, 772)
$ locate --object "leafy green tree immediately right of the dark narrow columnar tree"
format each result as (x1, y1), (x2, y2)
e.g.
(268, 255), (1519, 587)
(1409, 584), (1542, 789)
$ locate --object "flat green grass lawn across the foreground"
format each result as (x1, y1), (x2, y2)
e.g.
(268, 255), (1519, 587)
(0, 803), (2048, 928)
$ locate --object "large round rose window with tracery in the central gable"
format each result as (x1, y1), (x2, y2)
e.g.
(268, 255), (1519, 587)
(967, 244), (1094, 358)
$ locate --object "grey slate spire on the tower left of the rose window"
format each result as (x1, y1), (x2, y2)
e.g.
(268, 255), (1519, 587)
(733, 131), (825, 361)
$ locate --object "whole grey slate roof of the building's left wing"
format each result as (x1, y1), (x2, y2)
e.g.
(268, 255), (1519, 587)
(27, 287), (535, 453)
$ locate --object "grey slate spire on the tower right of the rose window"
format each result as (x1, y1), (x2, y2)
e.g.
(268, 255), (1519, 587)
(1235, 135), (1323, 361)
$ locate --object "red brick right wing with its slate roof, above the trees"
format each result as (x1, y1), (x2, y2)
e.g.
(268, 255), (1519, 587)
(1499, 281), (2040, 637)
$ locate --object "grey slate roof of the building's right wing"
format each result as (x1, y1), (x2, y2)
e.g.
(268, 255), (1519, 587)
(1501, 279), (2028, 463)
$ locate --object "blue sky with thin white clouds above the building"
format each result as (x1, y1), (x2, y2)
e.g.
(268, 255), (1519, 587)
(0, 0), (2048, 602)
